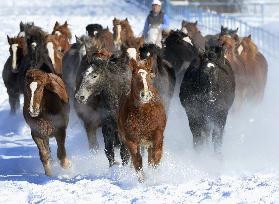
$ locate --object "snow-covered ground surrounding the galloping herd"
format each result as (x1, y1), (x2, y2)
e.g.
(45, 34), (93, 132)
(0, 0), (279, 204)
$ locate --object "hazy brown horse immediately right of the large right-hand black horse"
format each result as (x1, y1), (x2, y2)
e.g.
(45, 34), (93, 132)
(219, 35), (249, 111)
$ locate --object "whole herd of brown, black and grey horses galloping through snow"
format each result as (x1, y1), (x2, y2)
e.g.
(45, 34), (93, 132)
(2, 18), (268, 182)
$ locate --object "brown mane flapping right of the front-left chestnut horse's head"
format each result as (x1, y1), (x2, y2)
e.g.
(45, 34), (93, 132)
(46, 73), (69, 103)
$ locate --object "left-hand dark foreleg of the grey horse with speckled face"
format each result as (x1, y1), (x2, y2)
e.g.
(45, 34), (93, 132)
(102, 120), (118, 167)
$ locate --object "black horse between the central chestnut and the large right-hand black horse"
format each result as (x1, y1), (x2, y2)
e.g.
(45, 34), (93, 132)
(162, 30), (198, 85)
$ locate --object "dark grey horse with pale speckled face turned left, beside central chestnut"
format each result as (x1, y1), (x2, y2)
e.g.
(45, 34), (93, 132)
(75, 49), (131, 167)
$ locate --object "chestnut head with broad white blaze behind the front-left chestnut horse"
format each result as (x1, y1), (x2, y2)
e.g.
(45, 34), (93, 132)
(46, 35), (64, 74)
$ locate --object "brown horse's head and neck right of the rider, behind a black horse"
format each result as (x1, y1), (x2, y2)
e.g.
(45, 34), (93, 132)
(181, 20), (205, 52)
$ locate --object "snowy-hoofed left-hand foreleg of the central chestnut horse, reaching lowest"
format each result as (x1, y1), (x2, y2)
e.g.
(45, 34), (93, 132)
(127, 141), (144, 183)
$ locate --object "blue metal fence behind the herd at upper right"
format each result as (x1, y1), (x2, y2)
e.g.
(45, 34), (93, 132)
(136, 0), (279, 57)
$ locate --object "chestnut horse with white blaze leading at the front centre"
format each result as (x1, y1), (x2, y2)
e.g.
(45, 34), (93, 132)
(118, 53), (166, 182)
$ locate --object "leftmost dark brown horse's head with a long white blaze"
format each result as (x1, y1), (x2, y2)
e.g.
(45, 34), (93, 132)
(7, 36), (27, 73)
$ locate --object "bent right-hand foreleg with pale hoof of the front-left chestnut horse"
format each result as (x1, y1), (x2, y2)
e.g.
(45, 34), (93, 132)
(55, 127), (71, 169)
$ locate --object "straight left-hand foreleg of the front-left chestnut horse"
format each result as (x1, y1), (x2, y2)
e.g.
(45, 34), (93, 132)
(31, 131), (51, 176)
